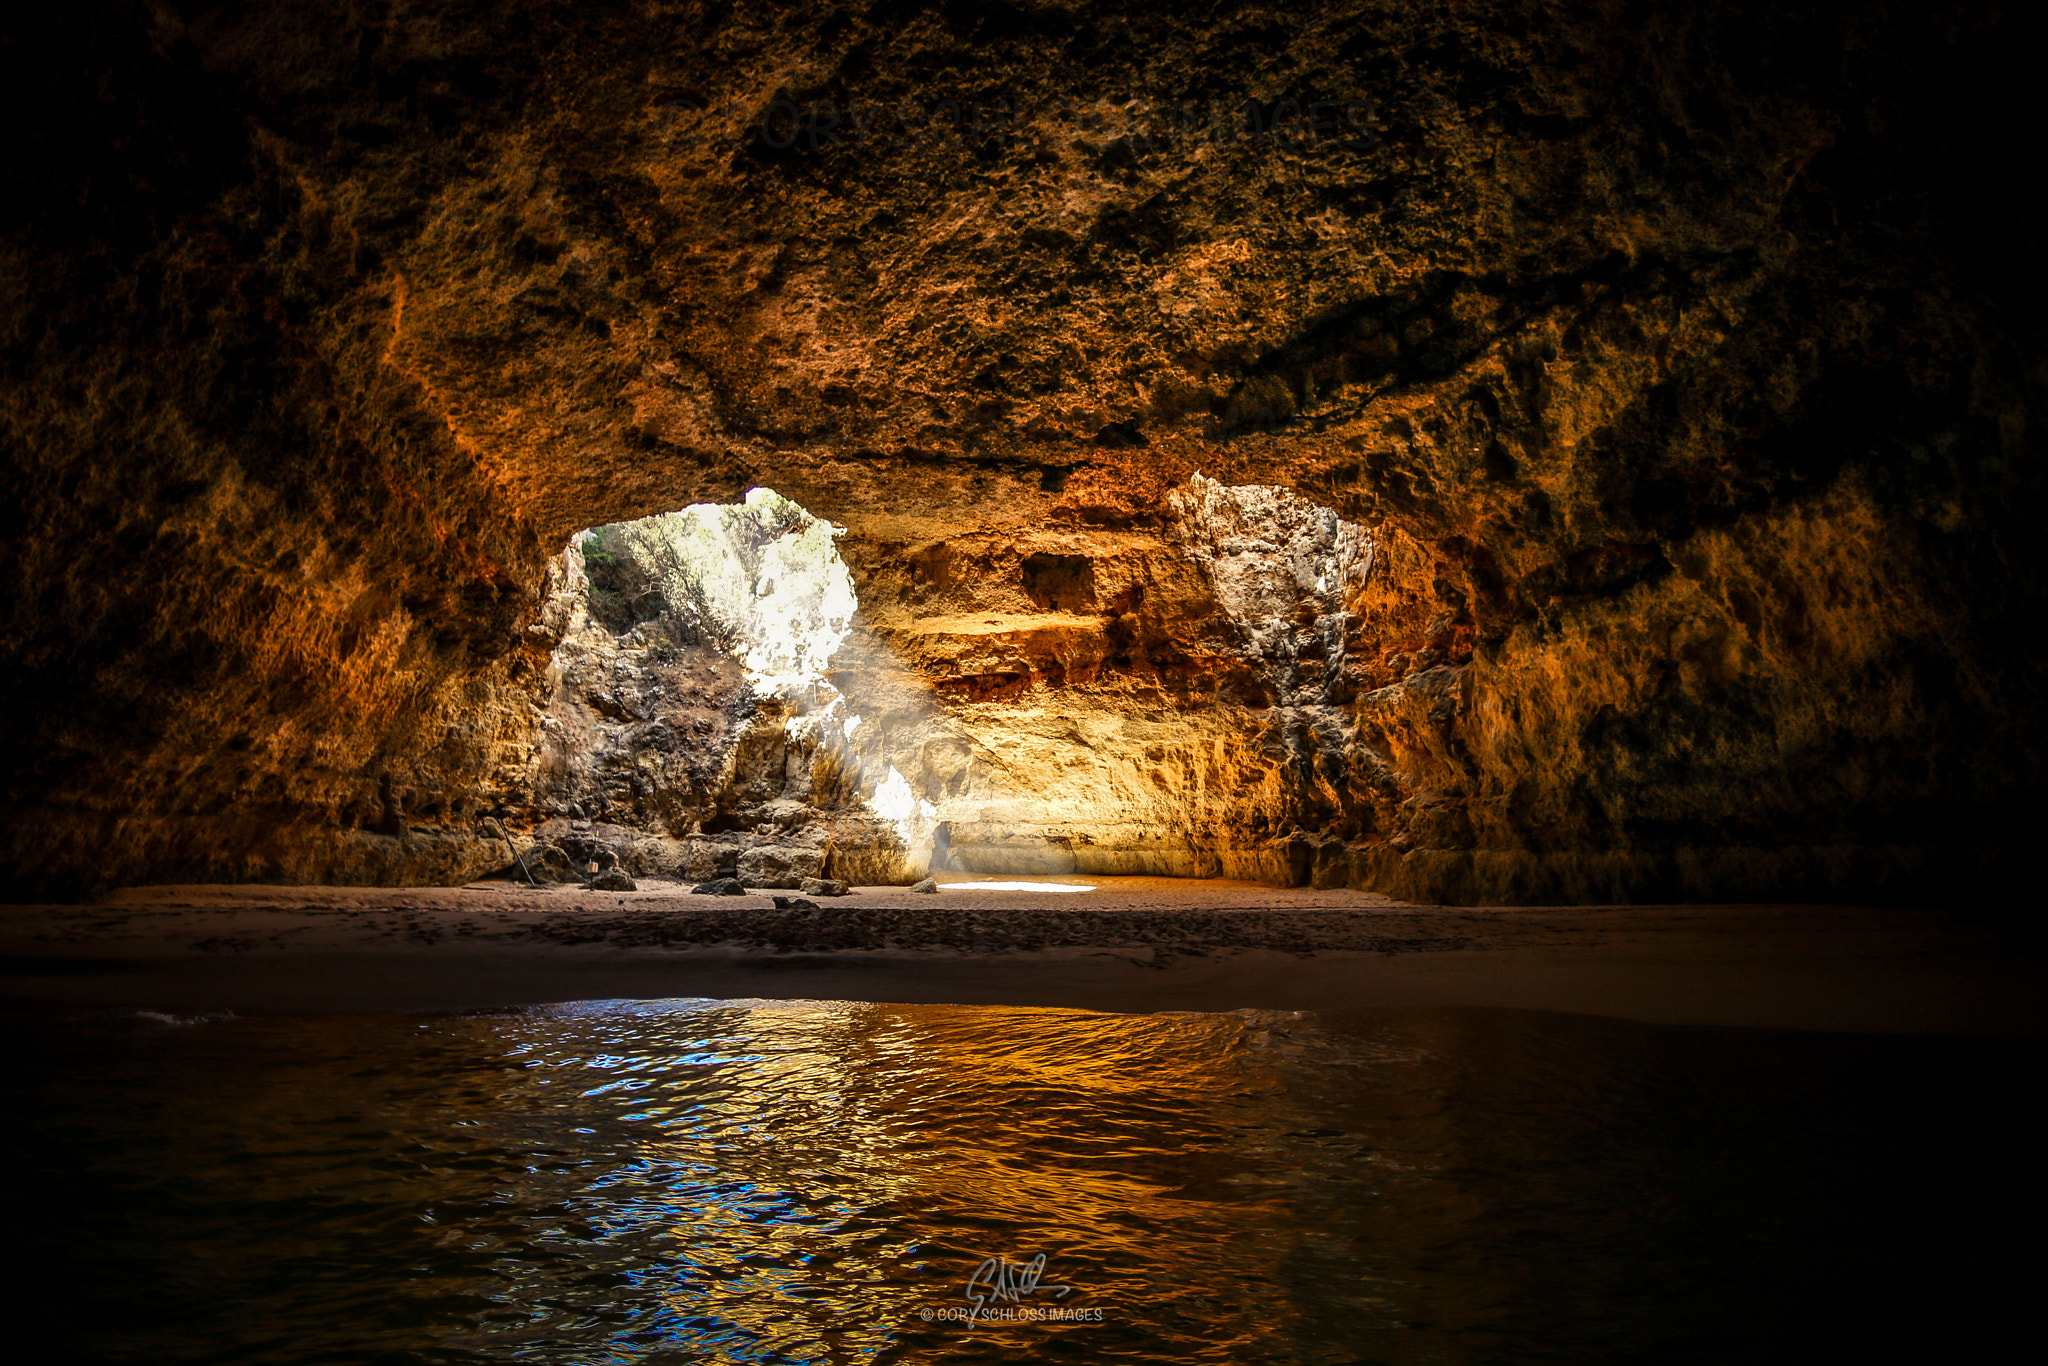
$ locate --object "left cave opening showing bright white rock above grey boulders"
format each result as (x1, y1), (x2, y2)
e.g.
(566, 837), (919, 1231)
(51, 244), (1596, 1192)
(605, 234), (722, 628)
(505, 487), (901, 889)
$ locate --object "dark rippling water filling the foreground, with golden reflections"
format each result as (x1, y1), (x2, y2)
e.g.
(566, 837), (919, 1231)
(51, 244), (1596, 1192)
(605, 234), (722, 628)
(4, 1001), (2042, 1366)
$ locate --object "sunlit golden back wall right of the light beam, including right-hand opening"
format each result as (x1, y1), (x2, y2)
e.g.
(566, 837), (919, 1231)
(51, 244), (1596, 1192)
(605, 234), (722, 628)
(842, 475), (1372, 877)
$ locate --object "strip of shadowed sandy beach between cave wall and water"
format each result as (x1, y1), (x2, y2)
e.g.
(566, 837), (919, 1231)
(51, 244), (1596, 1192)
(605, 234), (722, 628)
(0, 874), (2048, 1036)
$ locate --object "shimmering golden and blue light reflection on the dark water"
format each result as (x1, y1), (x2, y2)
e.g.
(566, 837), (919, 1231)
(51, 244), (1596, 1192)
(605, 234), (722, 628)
(444, 1004), (1288, 1356)
